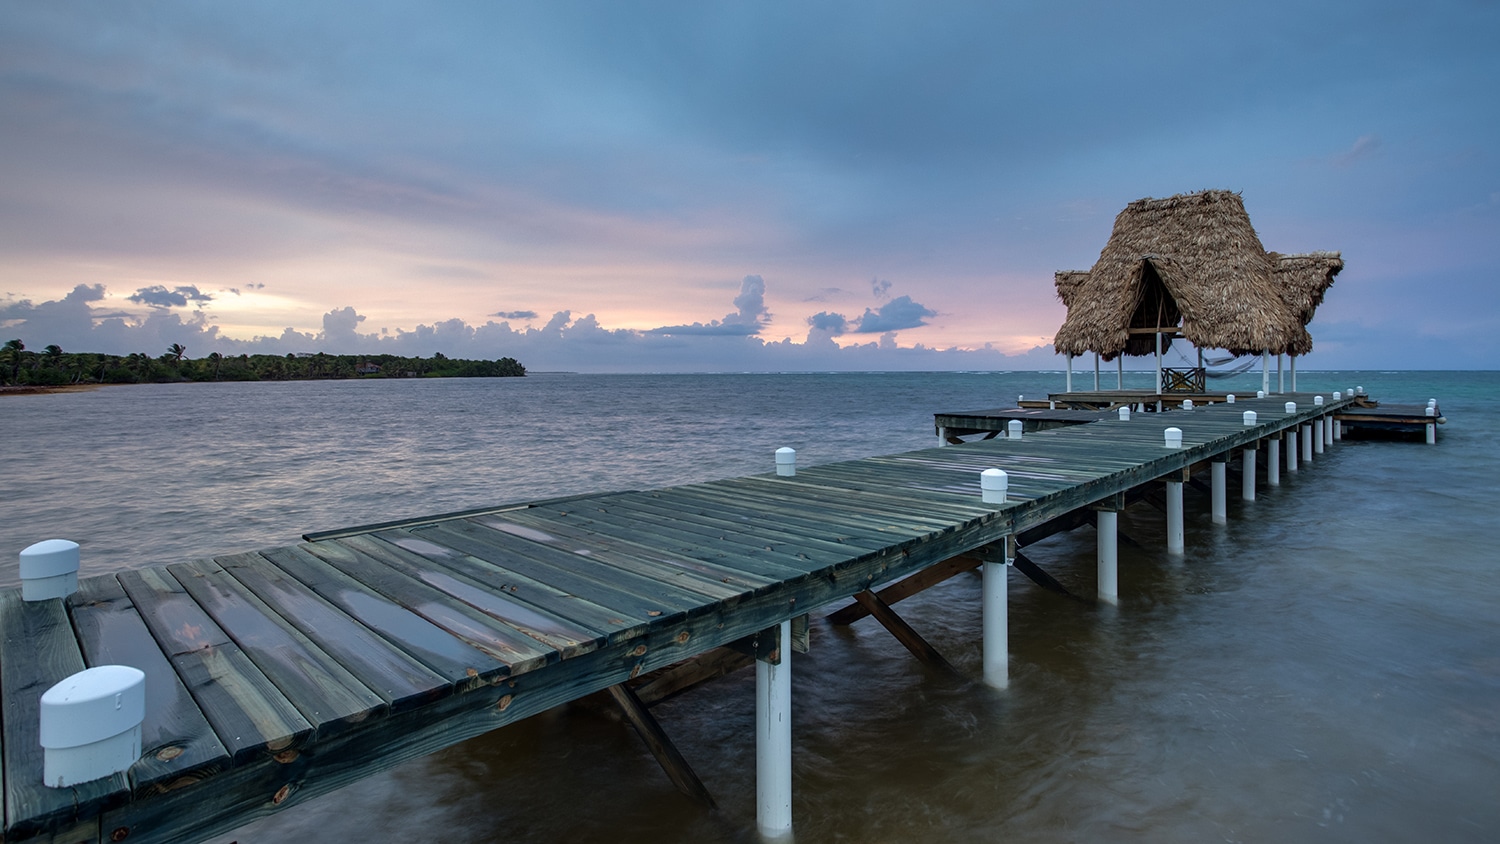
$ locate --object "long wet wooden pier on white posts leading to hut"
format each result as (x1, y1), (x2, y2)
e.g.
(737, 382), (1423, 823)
(0, 394), (1374, 843)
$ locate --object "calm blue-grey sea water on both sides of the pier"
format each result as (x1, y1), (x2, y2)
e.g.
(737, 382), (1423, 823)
(0, 372), (1500, 844)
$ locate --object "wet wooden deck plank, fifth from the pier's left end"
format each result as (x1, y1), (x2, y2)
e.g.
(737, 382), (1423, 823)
(215, 553), (453, 712)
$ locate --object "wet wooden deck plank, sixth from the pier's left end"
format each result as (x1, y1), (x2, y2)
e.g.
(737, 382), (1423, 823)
(261, 543), (510, 687)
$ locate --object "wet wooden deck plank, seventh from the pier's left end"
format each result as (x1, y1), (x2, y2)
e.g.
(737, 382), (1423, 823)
(279, 541), (560, 675)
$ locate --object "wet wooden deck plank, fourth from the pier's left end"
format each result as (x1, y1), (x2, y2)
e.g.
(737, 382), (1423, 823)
(167, 561), (387, 738)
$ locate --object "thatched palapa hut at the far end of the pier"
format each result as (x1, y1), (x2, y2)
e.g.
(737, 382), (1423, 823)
(1053, 190), (1344, 393)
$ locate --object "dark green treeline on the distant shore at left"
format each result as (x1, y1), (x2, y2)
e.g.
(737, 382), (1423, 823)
(0, 340), (527, 387)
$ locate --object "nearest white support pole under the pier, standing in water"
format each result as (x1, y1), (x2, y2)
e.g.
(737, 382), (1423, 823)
(755, 621), (792, 841)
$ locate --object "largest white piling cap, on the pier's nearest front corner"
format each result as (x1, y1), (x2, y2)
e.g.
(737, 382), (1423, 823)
(39, 666), (146, 789)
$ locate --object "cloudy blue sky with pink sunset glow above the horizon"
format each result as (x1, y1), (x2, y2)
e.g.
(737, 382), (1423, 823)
(0, 0), (1500, 372)
